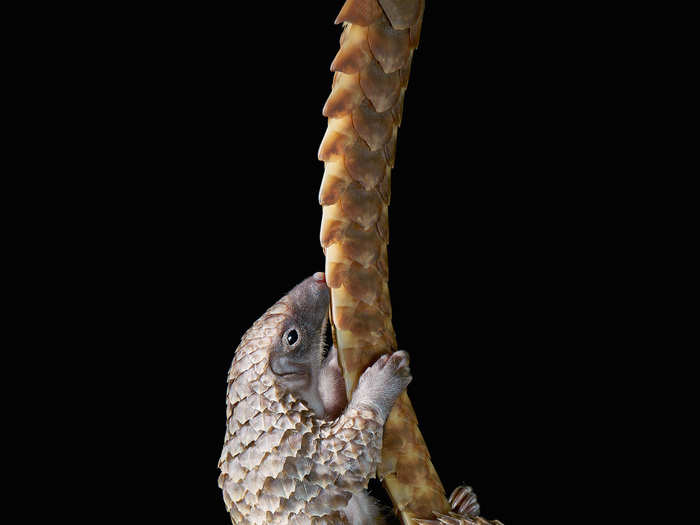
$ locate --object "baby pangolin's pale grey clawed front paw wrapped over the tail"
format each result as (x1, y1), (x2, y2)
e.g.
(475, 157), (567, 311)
(353, 350), (413, 422)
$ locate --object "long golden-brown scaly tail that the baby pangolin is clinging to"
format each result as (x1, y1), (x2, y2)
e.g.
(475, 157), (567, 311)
(319, 0), (451, 524)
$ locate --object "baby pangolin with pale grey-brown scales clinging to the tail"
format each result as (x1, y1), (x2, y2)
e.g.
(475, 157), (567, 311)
(219, 272), (411, 525)
